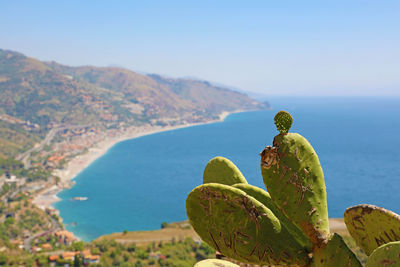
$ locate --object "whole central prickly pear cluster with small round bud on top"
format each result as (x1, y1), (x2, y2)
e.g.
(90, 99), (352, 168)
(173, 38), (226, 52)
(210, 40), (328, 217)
(186, 111), (361, 267)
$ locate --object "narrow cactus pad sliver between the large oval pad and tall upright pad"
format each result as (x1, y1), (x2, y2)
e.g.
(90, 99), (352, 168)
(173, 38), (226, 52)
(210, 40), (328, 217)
(233, 184), (313, 251)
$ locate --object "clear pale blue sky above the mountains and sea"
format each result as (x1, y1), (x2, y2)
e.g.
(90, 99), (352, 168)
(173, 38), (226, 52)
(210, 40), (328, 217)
(0, 0), (400, 96)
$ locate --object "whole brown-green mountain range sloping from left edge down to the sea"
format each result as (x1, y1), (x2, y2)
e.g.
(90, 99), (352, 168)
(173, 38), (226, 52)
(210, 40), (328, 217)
(0, 49), (267, 157)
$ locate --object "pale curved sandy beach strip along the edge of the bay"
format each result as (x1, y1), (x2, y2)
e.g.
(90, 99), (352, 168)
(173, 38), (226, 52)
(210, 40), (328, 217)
(32, 110), (238, 215)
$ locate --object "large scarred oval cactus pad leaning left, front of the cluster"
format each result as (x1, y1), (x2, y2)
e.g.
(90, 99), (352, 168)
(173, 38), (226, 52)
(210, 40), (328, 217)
(186, 183), (309, 266)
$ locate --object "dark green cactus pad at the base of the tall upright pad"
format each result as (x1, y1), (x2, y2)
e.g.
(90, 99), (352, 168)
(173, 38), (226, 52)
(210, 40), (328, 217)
(311, 233), (362, 267)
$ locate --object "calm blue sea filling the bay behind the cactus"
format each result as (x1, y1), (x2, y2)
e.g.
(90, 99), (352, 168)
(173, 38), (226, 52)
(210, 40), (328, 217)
(55, 98), (400, 240)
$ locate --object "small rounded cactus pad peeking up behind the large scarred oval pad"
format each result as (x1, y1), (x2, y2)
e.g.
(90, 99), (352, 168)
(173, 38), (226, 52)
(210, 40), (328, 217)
(203, 157), (247, 185)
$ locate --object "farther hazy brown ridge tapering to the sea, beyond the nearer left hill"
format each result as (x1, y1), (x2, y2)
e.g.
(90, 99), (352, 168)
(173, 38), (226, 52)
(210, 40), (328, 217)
(48, 62), (264, 119)
